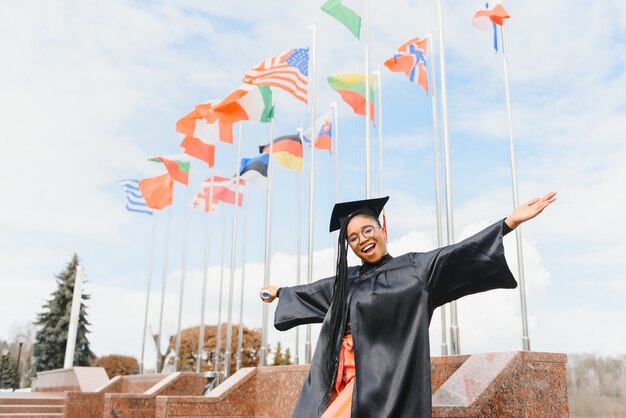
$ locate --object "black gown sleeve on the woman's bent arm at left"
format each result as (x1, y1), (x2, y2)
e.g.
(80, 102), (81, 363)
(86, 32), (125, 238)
(274, 277), (335, 331)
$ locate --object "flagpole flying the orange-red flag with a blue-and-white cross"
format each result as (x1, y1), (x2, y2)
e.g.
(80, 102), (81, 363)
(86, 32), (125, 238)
(426, 33), (448, 356)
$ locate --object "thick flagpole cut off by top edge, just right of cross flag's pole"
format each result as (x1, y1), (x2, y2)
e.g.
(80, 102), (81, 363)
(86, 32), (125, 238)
(436, 0), (461, 354)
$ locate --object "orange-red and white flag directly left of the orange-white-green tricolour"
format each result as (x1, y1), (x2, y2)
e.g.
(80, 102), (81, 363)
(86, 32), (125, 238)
(176, 109), (219, 167)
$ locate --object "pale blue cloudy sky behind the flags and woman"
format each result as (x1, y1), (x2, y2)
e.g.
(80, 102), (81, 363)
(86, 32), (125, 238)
(0, 0), (626, 372)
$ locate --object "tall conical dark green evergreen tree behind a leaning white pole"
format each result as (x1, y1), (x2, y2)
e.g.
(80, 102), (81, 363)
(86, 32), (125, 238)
(33, 254), (95, 372)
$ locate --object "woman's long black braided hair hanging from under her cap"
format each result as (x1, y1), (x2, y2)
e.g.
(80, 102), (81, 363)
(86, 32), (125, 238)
(320, 208), (380, 413)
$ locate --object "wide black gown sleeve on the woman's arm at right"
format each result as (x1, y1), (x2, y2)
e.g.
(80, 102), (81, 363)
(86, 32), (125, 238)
(422, 221), (517, 309)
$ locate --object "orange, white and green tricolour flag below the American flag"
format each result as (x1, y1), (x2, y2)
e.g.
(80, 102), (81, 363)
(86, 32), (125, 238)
(213, 84), (274, 124)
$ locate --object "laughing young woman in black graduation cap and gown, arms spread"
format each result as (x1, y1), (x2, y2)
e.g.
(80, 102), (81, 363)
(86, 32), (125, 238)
(261, 192), (556, 418)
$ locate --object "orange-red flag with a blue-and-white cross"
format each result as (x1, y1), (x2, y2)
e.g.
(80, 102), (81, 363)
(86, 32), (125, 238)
(385, 38), (428, 94)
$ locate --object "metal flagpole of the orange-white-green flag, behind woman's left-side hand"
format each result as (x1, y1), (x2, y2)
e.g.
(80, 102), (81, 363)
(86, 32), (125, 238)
(259, 88), (276, 366)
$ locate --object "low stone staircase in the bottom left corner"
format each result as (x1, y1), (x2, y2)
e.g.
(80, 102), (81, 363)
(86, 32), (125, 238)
(0, 392), (65, 418)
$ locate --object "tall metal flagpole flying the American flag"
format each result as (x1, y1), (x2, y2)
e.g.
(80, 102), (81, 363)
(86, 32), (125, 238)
(304, 23), (317, 363)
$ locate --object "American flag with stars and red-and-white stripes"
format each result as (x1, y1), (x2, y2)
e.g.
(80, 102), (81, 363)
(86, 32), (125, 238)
(243, 48), (309, 103)
